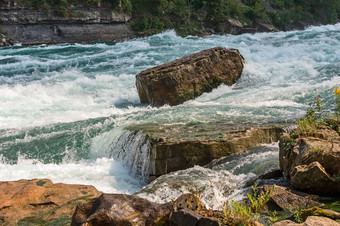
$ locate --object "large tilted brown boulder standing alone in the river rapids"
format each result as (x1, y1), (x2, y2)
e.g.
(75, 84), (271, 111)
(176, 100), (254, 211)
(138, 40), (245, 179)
(136, 47), (244, 107)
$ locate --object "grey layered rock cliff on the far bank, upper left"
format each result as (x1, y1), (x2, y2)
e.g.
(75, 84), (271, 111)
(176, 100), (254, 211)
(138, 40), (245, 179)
(0, 1), (135, 45)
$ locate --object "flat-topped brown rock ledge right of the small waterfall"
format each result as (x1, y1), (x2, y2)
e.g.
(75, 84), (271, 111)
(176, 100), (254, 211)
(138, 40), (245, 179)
(149, 126), (282, 180)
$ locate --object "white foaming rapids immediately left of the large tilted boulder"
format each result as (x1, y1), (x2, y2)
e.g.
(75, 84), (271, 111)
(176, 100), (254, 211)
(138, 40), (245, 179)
(0, 71), (139, 129)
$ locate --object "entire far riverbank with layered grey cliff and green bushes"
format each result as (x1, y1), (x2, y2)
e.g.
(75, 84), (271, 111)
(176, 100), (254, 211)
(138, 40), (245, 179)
(0, 0), (340, 46)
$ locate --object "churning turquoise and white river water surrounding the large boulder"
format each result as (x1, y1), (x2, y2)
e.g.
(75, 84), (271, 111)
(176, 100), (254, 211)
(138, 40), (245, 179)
(0, 24), (340, 201)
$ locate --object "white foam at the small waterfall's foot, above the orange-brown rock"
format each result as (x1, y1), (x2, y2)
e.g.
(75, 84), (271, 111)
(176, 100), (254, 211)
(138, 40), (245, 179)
(0, 158), (142, 194)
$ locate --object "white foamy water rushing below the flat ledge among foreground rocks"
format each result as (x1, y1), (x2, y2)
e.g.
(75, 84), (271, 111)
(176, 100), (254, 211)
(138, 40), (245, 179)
(136, 143), (278, 209)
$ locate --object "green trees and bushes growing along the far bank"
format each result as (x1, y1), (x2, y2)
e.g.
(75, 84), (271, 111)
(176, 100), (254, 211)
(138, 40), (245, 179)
(15, 0), (340, 35)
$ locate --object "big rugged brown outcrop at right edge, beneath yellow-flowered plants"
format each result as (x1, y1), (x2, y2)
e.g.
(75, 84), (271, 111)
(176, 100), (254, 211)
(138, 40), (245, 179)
(280, 123), (340, 194)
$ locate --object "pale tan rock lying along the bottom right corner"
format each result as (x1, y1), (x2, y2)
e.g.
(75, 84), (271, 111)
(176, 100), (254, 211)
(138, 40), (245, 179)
(272, 216), (340, 226)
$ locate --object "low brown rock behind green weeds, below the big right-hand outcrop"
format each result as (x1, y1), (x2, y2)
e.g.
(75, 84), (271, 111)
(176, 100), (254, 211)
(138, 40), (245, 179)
(262, 185), (321, 211)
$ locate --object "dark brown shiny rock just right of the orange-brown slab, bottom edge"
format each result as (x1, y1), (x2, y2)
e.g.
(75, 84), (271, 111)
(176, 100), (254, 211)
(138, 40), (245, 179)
(71, 194), (171, 226)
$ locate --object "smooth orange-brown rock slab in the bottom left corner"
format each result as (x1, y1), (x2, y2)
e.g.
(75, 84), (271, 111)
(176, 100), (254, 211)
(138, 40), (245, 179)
(0, 179), (100, 225)
